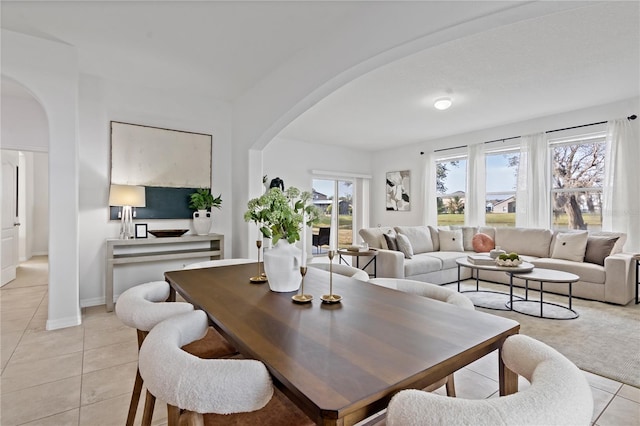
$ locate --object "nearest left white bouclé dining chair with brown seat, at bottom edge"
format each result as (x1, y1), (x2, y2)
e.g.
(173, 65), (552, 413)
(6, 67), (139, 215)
(140, 311), (315, 426)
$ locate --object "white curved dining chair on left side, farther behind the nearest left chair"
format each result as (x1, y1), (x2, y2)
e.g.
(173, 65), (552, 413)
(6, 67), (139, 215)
(115, 281), (236, 426)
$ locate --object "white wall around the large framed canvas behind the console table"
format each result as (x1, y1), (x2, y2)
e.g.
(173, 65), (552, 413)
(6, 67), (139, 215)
(79, 75), (236, 306)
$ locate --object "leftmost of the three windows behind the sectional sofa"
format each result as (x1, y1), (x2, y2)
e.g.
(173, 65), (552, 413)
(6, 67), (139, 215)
(436, 157), (467, 226)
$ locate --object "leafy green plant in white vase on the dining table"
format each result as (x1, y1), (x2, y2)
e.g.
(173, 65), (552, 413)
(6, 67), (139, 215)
(244, 187), (319, 292)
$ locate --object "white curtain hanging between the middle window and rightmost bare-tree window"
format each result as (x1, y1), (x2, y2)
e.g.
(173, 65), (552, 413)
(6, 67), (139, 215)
(516, 133), (551, 229)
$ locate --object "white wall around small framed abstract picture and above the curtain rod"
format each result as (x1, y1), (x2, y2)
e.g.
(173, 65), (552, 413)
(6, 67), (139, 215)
(371, 98), (640, 231)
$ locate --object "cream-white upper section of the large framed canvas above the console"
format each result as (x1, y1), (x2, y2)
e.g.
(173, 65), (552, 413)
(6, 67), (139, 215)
(111, 121), (212, 188)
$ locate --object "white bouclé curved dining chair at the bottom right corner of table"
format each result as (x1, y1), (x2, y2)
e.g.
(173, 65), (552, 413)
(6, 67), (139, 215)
(387, 334), (593, 426)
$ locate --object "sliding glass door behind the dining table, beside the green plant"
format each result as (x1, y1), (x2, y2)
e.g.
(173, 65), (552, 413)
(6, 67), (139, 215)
(313, 179), (354, 255)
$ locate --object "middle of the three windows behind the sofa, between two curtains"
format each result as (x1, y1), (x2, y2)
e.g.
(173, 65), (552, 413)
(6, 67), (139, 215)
(485, 150), (520, 226)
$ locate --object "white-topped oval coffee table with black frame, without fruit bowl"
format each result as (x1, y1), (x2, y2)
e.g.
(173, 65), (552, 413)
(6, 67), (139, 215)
(507, 268), (580, 320)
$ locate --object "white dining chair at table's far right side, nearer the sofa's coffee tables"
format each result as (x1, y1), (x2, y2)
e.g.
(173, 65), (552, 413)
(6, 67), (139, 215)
(369, 278), (475, 397)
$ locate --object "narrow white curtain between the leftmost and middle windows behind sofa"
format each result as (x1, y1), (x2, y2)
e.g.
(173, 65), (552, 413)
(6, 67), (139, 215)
(464, 144), (487, 226)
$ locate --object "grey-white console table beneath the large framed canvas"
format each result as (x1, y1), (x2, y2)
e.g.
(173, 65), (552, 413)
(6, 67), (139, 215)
(104, 234), (224, 312)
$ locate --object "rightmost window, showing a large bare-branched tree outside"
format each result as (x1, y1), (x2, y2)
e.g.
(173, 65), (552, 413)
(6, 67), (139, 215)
(549, 133), (605, 230)
